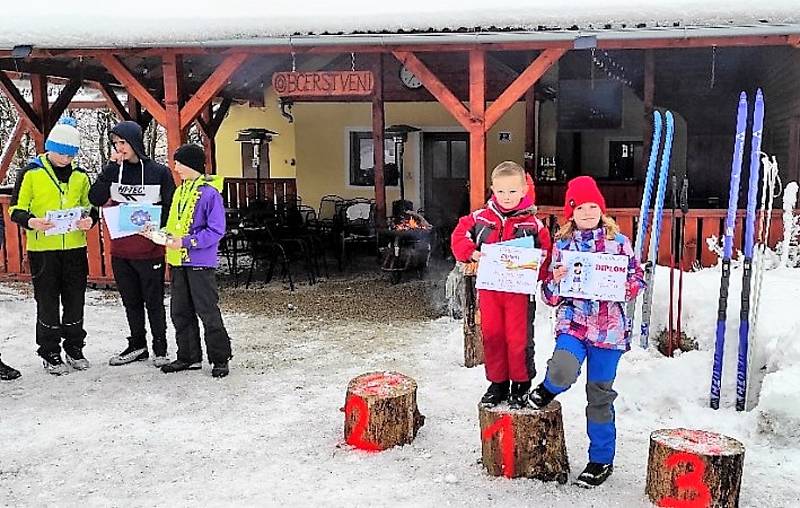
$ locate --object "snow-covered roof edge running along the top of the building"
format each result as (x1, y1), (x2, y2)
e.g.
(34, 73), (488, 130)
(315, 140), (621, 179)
(0, 0), (800, 49)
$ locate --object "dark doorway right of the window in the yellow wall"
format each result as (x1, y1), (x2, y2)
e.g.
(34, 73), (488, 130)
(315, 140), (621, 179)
(422, 132), (469, 243)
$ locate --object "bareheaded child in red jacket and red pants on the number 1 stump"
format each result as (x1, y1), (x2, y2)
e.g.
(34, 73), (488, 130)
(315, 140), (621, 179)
(451, 161), (550, 409)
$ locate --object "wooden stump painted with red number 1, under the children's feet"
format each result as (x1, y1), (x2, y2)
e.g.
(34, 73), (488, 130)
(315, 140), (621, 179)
(478, 401), (569, 484)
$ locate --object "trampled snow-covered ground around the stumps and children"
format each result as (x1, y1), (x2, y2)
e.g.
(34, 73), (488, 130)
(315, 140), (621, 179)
(0, 269), (800, 507)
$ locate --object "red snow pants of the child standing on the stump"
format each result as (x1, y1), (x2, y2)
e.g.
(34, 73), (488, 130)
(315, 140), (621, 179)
(478, 289), (535, 383)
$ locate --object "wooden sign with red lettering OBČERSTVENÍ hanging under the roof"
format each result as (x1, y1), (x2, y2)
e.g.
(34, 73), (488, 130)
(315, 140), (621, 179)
(272, 71), (375, 97)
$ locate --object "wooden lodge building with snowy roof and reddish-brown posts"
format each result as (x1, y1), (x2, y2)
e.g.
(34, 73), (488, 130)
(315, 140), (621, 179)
(0, 0), (800, 280)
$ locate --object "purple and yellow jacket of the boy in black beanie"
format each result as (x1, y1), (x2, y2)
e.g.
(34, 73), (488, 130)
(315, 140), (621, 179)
(167, 176), (225, 268)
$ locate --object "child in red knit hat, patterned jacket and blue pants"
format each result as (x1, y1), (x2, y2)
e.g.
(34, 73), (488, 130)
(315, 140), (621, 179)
(530, 176), (644, 487)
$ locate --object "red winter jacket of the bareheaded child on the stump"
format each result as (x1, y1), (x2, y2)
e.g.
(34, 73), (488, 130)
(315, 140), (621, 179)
(450, 200), (552, 280)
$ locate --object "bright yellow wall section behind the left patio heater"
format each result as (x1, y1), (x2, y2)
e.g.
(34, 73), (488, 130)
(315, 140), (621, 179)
(215, 89), (296, 178)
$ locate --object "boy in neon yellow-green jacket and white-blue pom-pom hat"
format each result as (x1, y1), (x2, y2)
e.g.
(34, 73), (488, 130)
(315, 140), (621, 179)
(9, 118), (98, 376)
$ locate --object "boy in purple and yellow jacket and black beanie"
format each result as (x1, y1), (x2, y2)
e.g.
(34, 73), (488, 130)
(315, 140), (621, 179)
(156, 144), (231, 377)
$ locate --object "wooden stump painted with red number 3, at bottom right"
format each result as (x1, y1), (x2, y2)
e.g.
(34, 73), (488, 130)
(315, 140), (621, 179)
(646, 429), (744, 508)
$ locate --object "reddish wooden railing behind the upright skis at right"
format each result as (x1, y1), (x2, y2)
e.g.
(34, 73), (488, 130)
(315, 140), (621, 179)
(538, 206), (783, 270)
